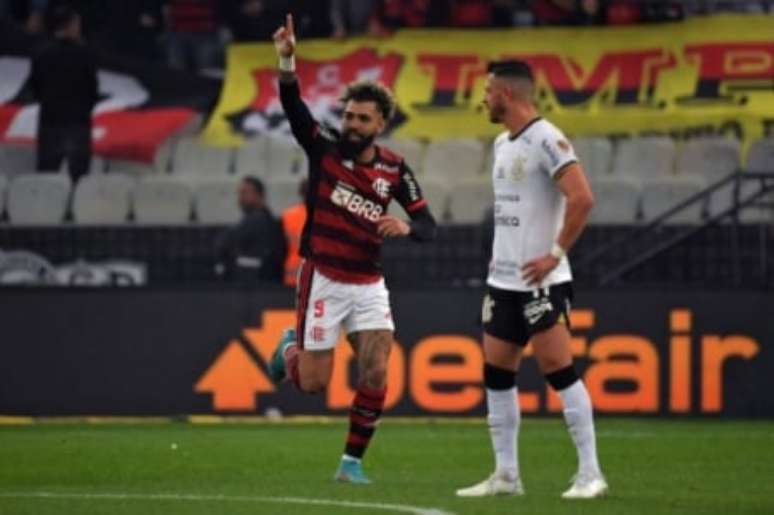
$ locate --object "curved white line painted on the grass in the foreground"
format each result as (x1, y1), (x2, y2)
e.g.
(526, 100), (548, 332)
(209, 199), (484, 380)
(0, 492), (454, 515)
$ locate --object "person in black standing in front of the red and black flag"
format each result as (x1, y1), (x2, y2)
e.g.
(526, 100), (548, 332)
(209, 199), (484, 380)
(30, 3), (98, 181)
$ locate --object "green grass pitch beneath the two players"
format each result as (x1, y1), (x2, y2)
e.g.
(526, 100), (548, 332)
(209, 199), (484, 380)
(0, 419), (774, 515)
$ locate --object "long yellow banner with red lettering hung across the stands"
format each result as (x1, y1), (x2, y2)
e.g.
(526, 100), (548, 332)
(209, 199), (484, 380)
(205, 15), (774, 146)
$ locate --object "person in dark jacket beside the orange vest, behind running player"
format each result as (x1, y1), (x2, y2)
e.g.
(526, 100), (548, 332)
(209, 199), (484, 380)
(216, 177), (286, 285)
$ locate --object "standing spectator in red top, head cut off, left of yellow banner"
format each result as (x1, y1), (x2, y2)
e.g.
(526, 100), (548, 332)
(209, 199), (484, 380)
(165, 0), (223, 72)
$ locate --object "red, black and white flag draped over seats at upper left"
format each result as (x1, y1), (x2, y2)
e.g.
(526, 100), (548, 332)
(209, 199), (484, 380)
(0, 21), (222, 162)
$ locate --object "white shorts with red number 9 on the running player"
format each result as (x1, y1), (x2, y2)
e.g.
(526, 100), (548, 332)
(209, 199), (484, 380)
(296, 261), (395, 350)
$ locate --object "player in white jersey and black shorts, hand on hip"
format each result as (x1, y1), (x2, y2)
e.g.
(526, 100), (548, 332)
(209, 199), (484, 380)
(457, 61), (608, 499)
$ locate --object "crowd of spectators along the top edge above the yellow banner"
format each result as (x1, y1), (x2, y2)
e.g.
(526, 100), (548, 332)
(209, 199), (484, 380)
(0, 0), (774, 70)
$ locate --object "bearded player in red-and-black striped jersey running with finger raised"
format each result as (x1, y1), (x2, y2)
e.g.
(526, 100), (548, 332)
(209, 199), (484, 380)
(269, 15), (436, 484)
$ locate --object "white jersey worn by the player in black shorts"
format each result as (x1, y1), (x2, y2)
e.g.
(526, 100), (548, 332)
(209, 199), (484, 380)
(487, 118), (577, 291)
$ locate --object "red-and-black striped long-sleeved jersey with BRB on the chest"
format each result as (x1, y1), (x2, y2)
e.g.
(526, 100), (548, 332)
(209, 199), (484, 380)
(280, 81), (434, 283)
